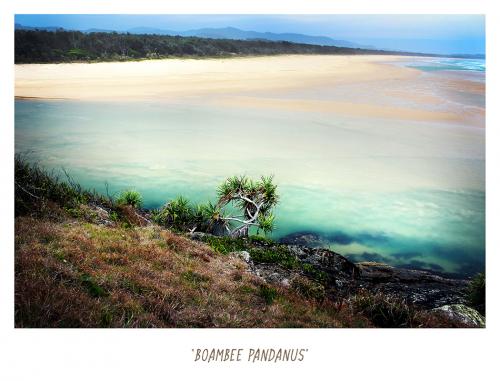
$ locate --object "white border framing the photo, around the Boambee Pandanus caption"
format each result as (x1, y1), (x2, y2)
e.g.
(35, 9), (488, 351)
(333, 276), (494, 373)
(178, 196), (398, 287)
(0, 0), (500, 380)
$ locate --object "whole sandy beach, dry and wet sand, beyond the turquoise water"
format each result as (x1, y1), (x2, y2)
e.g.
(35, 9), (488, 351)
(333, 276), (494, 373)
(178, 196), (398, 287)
(15, 55), (484, 125)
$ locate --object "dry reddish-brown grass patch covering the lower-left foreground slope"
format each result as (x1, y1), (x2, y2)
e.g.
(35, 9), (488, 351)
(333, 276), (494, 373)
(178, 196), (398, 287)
(15, 217), (352, 327)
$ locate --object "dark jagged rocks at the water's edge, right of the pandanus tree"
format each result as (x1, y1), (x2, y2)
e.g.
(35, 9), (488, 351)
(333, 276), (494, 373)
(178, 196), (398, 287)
(191, 233), (469, 310)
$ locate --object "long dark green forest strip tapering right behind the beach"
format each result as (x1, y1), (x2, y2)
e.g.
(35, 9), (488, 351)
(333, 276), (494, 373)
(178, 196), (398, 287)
(15, 30), (422, 63)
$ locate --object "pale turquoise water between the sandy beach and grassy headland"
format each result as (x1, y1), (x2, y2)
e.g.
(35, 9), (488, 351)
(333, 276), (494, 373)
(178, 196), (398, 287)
(15, 100), (485, 275)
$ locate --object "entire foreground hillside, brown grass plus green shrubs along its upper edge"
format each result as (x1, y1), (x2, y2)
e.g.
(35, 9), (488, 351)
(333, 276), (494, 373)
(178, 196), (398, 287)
(15, 157), (472, 327)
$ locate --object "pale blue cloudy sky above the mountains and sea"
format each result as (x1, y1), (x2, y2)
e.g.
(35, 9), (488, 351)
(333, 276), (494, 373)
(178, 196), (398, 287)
(15, 14), (485, 54)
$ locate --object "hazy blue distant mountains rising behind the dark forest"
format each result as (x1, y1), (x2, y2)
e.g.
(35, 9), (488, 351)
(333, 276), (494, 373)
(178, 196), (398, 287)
(15, 24), (376, 49)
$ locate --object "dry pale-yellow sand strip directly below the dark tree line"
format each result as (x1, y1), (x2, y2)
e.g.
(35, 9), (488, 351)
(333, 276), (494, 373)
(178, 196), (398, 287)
(15, 55), (412, 100)
